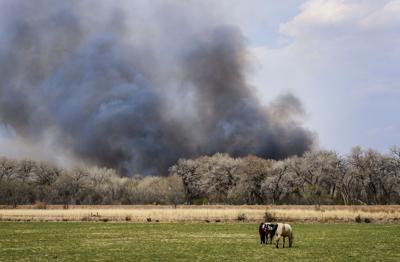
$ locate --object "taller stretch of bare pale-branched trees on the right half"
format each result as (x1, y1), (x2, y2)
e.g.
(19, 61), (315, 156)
(170, 147), (400, 205)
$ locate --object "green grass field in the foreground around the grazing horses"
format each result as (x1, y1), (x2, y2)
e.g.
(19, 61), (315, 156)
(0, 222), (400, 261)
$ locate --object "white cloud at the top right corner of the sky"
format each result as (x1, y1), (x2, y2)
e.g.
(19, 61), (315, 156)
(280, 0), (400, 37)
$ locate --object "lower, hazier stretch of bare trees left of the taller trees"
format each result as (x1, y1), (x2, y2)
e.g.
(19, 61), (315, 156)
(0, 158), (185, 206)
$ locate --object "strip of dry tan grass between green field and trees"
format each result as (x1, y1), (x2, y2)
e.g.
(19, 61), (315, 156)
(0, 205), (400, 223)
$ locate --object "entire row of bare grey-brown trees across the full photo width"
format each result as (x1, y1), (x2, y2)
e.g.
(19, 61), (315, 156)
(0, 147), (400, 205)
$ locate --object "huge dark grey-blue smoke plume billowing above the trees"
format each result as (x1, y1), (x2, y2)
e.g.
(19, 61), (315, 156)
(0, 0), (313, 175)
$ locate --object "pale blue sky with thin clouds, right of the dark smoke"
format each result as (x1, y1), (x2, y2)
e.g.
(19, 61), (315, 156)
(219, 0), (400, 153)
